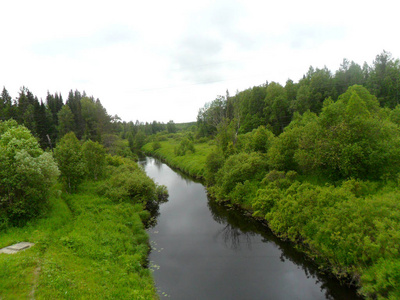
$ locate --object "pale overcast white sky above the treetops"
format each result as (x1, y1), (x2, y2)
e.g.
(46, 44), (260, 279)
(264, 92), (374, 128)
(0, 0), (400, 122)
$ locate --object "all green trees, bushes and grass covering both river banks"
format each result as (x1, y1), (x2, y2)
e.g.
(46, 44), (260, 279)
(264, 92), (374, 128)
(0, 51), (400, 299)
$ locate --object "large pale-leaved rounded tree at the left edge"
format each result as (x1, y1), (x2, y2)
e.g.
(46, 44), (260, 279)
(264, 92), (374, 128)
(0, 120), (59, 226)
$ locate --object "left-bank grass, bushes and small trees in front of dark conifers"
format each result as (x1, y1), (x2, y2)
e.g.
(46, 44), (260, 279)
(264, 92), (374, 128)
(0, 120), (166, 299)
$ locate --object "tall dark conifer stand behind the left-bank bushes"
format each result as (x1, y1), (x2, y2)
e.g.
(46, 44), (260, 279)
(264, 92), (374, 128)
(0, 87), (115, 149)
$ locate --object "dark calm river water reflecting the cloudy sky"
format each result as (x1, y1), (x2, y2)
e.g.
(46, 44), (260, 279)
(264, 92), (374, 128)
(140, 158), (360, 300)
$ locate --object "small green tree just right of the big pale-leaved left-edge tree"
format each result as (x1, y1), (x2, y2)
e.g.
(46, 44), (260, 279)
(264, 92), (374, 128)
(54, 132), (85, 193)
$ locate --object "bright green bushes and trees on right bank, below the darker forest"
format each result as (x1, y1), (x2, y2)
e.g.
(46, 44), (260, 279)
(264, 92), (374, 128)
(206, 85), (400, 299)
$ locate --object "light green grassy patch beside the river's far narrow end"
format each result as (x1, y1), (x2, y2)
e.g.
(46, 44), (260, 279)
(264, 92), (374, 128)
(142, 138), (216, 178)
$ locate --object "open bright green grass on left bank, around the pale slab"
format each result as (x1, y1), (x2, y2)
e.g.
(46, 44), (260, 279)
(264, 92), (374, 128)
(0, 182), (157, 299)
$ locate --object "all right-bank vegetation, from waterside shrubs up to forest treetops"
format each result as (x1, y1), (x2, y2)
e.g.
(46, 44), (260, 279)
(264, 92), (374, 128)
(143, 52), (400, 299)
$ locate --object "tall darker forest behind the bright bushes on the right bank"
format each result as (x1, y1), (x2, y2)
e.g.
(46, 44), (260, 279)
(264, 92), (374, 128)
(197, 51), (400, 136)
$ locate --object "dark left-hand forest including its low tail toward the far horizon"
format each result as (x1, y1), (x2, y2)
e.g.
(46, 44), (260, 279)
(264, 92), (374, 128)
(0, 87), (175, 156)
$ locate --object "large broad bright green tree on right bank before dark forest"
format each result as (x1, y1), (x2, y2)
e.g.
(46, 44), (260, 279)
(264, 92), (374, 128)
(295, 85), (400, 179)
